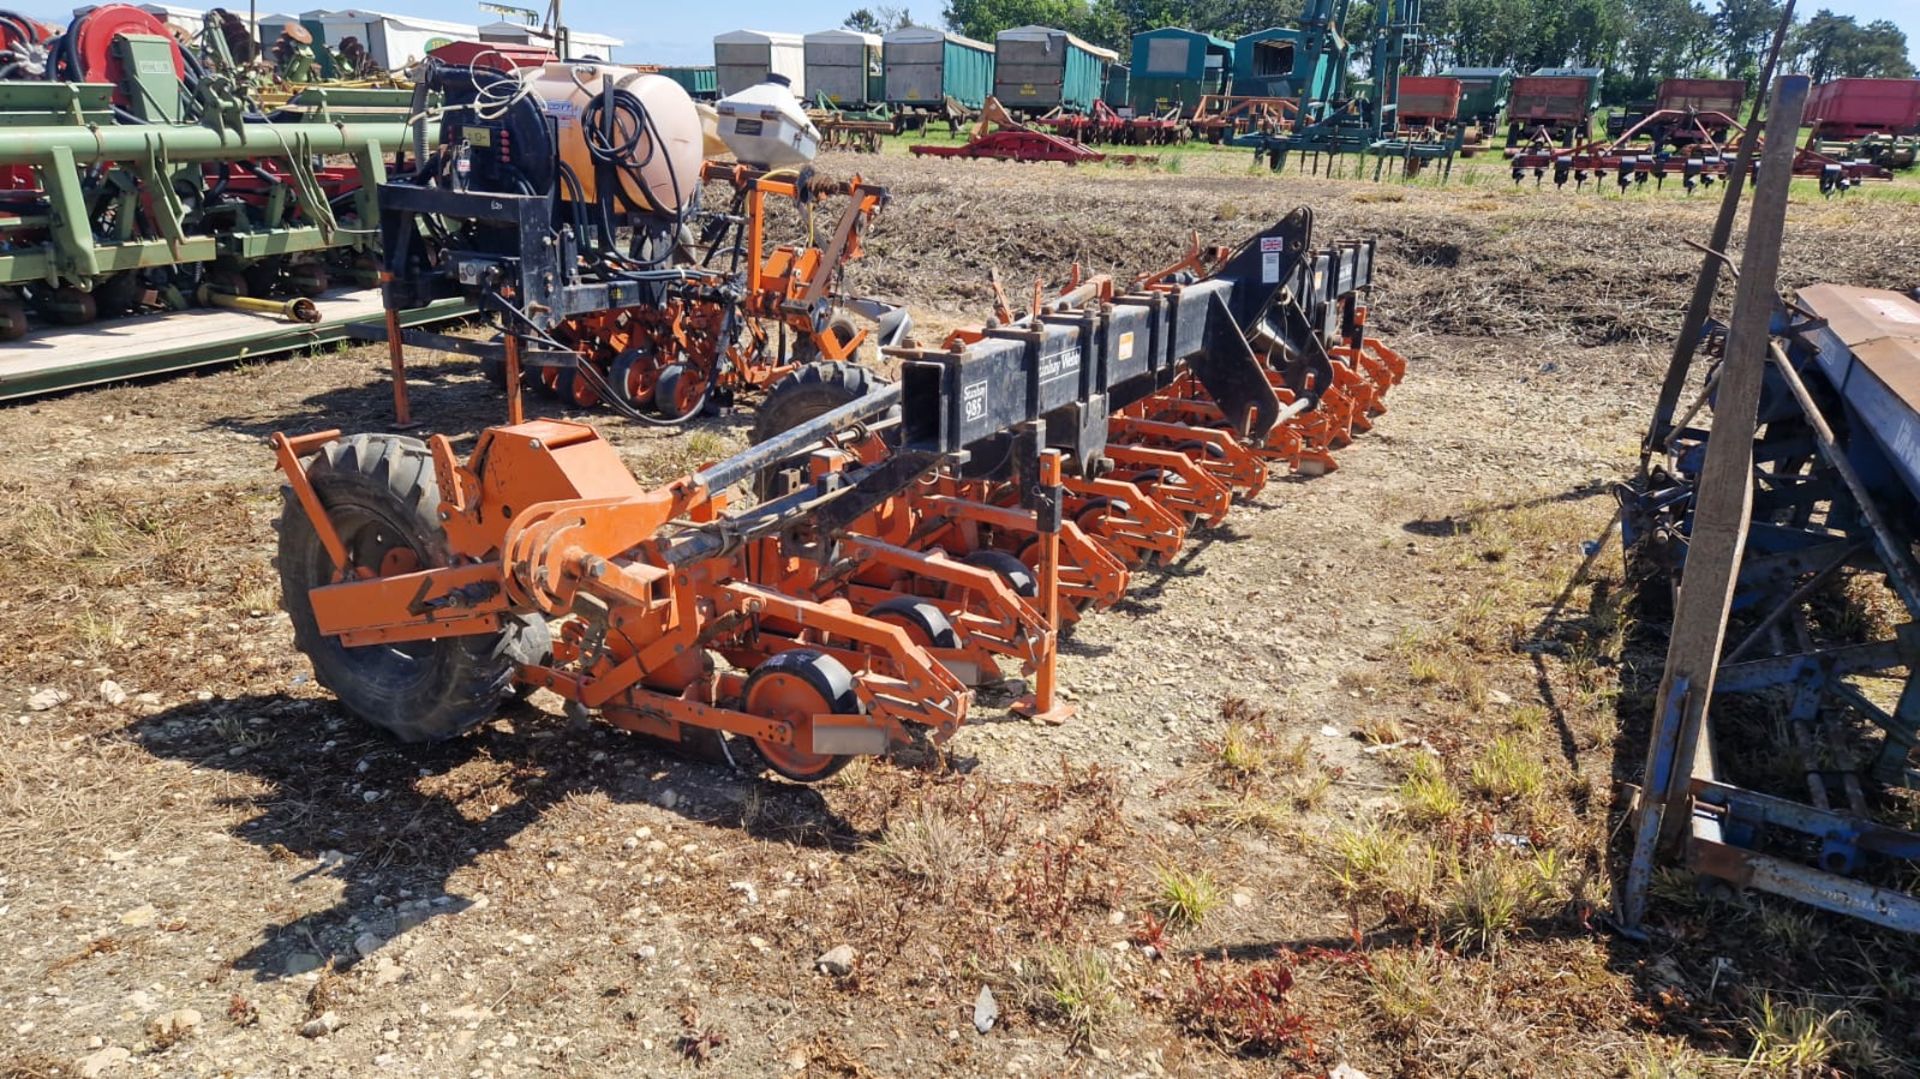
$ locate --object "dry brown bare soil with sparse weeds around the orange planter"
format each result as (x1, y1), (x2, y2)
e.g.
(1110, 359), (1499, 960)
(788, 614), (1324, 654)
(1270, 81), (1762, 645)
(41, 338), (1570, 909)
(0, 152), (1920, 1077)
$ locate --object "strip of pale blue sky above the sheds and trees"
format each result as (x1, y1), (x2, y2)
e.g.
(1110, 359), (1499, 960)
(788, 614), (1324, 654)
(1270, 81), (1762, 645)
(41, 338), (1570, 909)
(18, 0), (1920, 63)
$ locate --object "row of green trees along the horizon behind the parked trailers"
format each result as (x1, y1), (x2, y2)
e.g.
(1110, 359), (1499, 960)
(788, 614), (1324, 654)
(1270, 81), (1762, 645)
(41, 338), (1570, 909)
(847, 0), (1914, 102)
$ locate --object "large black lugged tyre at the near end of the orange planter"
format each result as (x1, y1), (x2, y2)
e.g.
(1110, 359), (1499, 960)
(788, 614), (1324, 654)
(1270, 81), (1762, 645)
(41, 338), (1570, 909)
(276, 434), (551, 741)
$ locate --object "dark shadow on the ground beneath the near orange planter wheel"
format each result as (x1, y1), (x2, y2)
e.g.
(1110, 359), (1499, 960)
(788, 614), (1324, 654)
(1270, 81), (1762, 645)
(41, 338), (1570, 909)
(129, 693), (872, 979)
